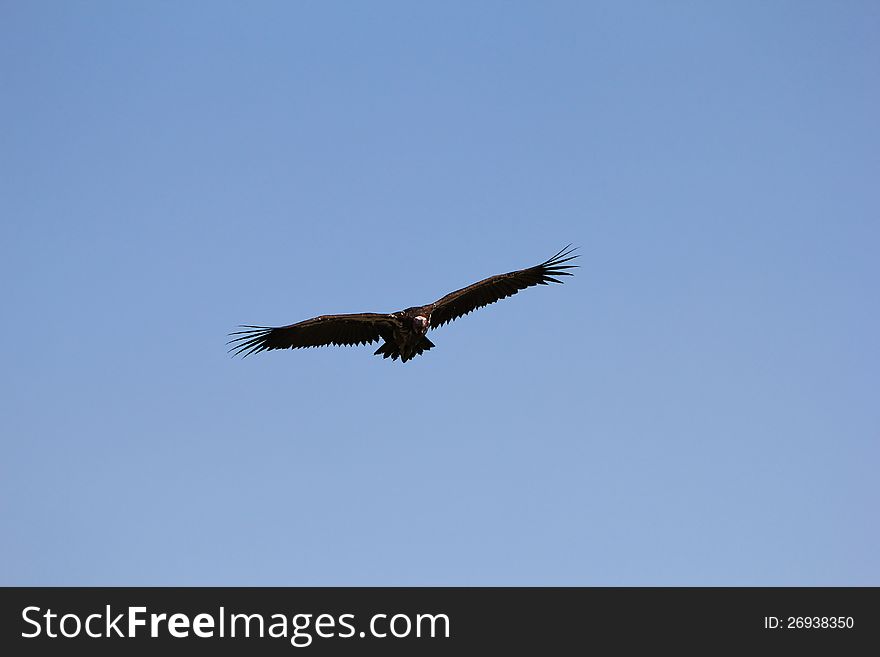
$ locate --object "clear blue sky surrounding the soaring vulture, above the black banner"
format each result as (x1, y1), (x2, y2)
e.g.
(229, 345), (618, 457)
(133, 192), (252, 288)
(0, 1), (880, 585)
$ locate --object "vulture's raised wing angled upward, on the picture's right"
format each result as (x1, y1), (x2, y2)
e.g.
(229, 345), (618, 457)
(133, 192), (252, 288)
(431, 244), (578, 328)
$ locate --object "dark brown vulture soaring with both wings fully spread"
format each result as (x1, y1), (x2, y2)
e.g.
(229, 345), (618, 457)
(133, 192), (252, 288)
(227, 244), (578, 363)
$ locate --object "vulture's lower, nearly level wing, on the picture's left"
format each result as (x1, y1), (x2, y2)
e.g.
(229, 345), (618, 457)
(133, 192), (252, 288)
(227, 313), (396, 356)
